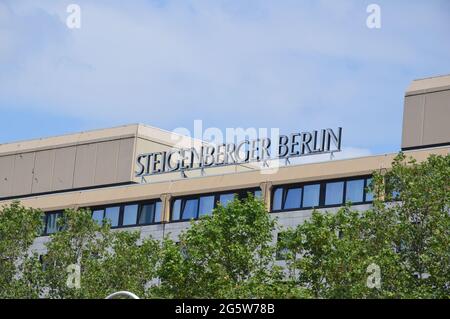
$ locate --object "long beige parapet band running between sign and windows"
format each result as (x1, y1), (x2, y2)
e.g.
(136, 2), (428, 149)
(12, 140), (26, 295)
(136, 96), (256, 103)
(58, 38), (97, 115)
(0, 147), (450, 215)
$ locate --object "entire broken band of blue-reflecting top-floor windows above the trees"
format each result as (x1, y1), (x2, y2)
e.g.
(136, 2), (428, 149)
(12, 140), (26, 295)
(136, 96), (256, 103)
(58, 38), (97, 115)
(43, 176), (373, 234)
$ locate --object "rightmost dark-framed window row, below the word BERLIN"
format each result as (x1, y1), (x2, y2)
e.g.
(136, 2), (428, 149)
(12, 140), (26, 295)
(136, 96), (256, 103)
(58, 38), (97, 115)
(272, 177), (373, 212)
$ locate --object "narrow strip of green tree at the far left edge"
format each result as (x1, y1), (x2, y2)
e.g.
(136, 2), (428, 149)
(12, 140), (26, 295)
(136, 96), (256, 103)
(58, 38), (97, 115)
(0, 202), (43, 298)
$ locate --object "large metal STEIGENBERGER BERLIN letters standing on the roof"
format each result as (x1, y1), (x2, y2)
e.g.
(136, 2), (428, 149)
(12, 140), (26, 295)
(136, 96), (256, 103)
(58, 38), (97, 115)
(135, 127), (342, 177)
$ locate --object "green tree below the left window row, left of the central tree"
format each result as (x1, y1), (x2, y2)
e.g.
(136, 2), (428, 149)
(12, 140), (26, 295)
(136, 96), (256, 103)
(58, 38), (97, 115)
(42, 210), (158, 298)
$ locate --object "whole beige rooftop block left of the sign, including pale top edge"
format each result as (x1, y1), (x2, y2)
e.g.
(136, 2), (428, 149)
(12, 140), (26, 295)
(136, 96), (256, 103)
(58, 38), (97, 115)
(0, 124), (207, 198)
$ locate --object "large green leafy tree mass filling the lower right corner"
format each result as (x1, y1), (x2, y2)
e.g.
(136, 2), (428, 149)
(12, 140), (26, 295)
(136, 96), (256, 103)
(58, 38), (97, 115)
(281, 153), (450, 298)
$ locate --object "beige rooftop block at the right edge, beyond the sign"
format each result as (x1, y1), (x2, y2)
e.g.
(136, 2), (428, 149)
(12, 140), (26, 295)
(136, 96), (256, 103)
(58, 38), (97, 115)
(402, 76), (450, 149)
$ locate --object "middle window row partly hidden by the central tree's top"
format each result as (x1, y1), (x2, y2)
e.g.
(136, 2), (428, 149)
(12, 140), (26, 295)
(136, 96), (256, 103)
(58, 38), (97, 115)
(171, 189), (262, 221)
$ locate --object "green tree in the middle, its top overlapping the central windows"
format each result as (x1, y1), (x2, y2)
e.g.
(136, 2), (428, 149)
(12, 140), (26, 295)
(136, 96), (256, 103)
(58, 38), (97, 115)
(157, 194), (298, 298)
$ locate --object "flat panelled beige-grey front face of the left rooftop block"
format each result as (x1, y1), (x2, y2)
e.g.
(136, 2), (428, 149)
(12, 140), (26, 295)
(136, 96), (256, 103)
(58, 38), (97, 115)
(0, 138), (135, 197)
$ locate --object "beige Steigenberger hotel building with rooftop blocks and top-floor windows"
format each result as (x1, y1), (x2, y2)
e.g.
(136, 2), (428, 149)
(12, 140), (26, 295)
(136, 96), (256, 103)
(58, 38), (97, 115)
(0, 76), (450, 252)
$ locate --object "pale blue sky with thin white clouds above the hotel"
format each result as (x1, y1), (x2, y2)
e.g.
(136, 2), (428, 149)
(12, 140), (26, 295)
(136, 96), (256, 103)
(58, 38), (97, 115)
(0, 0), (450, 156)
